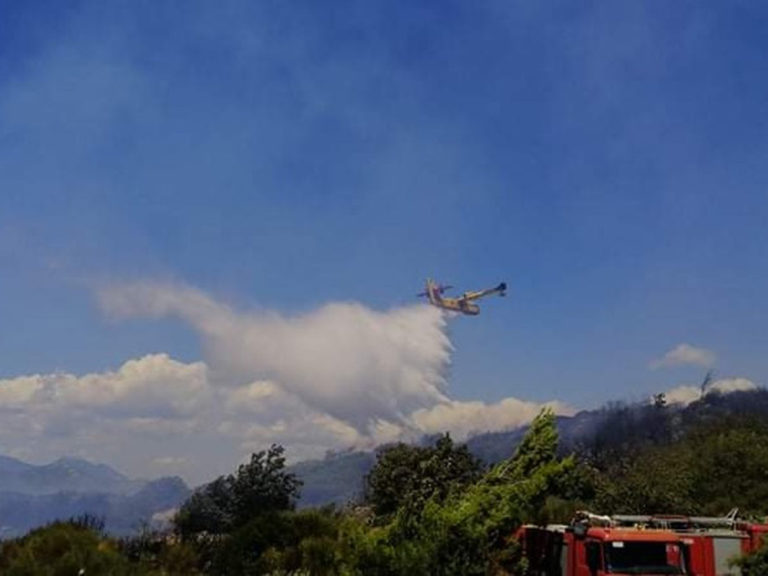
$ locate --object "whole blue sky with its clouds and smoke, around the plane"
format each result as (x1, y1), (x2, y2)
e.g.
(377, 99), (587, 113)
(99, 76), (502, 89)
(0, 0), (768, 483)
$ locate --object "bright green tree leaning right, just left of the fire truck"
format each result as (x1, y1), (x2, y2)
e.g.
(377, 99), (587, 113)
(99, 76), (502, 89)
(345, 410), (578, 576)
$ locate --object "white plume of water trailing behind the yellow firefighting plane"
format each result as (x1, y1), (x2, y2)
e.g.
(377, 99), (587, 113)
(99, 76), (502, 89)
(100, 283), (451, 433)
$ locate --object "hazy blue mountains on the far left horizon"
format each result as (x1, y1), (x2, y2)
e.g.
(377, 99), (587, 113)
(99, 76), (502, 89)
(0, 456), (190, 538)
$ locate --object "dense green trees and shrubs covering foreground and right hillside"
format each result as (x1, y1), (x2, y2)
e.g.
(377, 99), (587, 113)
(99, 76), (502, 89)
(0, 391), (768, 576)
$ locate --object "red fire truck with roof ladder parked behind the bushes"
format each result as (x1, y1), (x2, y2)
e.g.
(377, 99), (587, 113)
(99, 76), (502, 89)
(518, 510), (768, 576)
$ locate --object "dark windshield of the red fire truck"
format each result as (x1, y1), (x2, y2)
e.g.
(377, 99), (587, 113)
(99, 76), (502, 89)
(605, 542), (685, 574)
